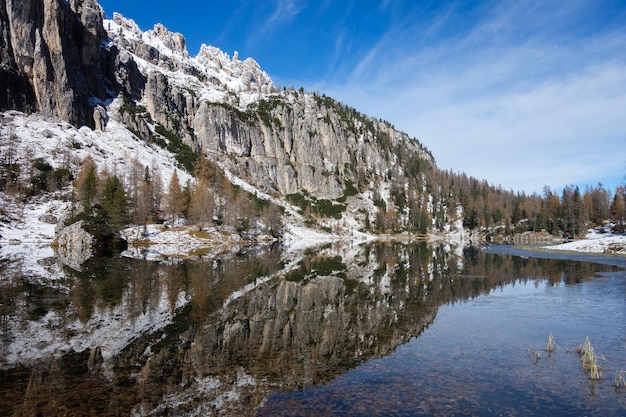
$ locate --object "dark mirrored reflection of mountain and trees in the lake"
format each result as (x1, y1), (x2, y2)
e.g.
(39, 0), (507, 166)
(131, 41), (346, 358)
(0, 239), (613, 415)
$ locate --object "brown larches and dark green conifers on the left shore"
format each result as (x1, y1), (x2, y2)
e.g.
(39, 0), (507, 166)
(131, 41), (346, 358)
(66, 157), (282, 247)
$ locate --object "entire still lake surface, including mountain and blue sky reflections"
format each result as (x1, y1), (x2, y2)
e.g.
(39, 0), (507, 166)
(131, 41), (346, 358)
(0, 243), (626, 416)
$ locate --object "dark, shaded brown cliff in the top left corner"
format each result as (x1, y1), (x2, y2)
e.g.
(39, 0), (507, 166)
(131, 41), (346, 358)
(0, 0), (106, 127)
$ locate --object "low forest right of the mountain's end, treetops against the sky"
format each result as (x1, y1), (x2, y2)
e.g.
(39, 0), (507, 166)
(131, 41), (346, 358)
(422, 171), (626, 238)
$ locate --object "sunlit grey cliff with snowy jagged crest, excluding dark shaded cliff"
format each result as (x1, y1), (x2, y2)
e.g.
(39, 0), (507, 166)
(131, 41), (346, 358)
(105, 14), (434, 198)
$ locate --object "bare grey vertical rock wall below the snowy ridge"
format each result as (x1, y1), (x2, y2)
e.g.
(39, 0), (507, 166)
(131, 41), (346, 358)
(192, 96), (434, 198)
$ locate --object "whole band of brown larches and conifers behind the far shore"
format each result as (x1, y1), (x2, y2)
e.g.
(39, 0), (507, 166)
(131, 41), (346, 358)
(0, 127), (626, 241)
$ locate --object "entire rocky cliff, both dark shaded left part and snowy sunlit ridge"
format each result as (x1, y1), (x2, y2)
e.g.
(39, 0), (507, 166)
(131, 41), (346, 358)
(0, 0), (434, 224)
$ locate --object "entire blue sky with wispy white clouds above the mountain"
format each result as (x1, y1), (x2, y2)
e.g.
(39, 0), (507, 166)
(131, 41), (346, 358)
(100, 0), (626, 193)
